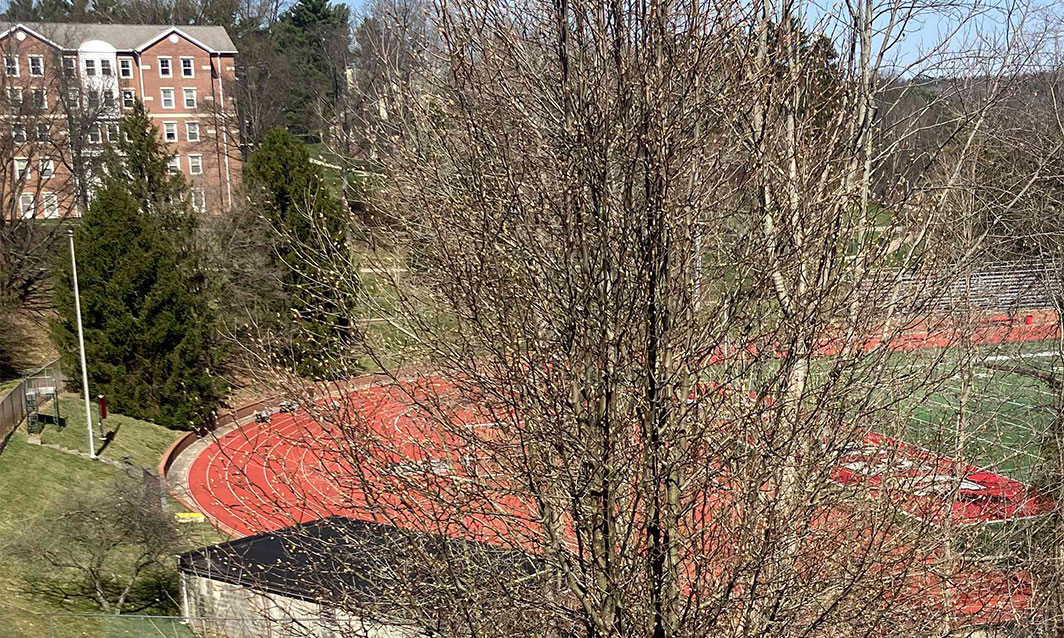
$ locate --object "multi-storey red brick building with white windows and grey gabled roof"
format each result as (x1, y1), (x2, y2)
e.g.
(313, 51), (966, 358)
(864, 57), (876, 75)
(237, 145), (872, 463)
(0, 22), (240, 218)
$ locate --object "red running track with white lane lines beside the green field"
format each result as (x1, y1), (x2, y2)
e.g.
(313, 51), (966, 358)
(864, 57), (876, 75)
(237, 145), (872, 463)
(188, 313), (1057, 540)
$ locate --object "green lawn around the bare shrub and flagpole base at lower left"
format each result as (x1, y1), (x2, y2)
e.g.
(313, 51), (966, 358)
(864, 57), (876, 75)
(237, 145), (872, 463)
(0, 406), (225, 638)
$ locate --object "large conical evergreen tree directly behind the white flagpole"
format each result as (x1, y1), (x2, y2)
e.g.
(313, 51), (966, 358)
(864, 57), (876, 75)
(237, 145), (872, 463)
(52, 102), (223, 429)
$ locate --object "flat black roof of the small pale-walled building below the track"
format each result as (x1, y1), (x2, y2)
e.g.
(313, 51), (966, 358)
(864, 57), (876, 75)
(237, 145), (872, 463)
(178, 516), (537, 605)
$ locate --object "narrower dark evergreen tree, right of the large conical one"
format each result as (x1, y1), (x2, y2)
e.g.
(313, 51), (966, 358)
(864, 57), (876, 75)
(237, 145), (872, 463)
(244, 129), (351, 379)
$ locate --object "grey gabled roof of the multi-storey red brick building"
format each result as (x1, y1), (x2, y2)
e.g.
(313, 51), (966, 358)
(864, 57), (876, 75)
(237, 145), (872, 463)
(0, 22), (236, 53)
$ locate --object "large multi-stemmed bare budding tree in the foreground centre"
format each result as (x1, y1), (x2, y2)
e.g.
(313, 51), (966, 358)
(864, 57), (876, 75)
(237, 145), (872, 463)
(213, 0), (1064, 638)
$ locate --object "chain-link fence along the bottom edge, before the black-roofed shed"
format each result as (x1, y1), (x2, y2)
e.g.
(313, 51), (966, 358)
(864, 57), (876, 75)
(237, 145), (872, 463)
(43, 614), (331, 638)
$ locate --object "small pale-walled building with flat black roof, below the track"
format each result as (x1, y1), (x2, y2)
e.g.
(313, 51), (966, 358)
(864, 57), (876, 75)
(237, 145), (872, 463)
(178, 516), (536, 638)
